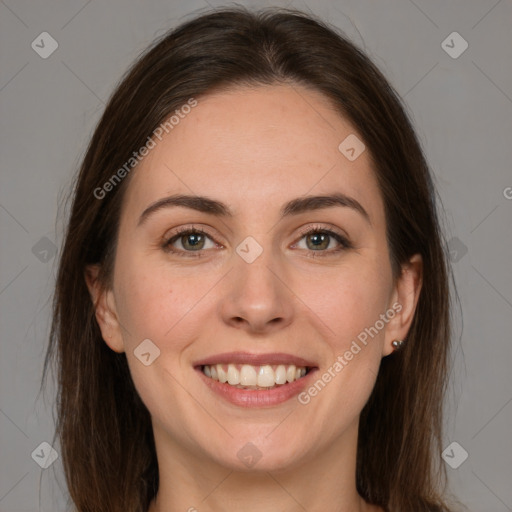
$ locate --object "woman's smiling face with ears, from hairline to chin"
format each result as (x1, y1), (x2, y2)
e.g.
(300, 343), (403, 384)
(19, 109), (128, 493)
(90, 86), (422, 470)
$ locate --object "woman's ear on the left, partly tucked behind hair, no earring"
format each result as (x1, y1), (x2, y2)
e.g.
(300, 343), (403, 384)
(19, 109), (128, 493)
(85, 265), (124, 353)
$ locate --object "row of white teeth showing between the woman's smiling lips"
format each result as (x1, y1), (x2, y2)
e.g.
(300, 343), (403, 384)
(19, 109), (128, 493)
(200, 364), (311, 390)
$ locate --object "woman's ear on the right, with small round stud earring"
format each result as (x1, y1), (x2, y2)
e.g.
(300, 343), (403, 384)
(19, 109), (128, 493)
(382, 254), (423, 356)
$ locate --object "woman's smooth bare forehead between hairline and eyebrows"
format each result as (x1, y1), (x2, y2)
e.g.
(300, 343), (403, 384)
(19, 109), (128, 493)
(122, 85), (382, 224)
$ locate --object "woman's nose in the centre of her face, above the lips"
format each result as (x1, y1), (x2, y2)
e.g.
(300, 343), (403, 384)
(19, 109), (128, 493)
(221, 245), (294, 335)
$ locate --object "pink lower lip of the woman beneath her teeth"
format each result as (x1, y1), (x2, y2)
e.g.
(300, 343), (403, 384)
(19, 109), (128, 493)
(196, 368), (317, 407)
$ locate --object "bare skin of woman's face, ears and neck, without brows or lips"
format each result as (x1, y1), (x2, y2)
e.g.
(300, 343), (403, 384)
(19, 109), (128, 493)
(87, 85), (422, 512)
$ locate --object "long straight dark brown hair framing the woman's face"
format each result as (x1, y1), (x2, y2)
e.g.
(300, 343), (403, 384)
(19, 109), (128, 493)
(43, 7), (458, 512)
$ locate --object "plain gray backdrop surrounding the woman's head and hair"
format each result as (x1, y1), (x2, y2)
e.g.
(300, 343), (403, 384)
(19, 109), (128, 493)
(0, 0), (512, 512)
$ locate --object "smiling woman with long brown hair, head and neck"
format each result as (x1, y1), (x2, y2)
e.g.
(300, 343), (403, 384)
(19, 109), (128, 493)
(45, 8), (460, 512)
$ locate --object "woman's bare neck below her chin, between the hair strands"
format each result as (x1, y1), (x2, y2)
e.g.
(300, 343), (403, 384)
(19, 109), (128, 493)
(149, 423), (380, 512)
